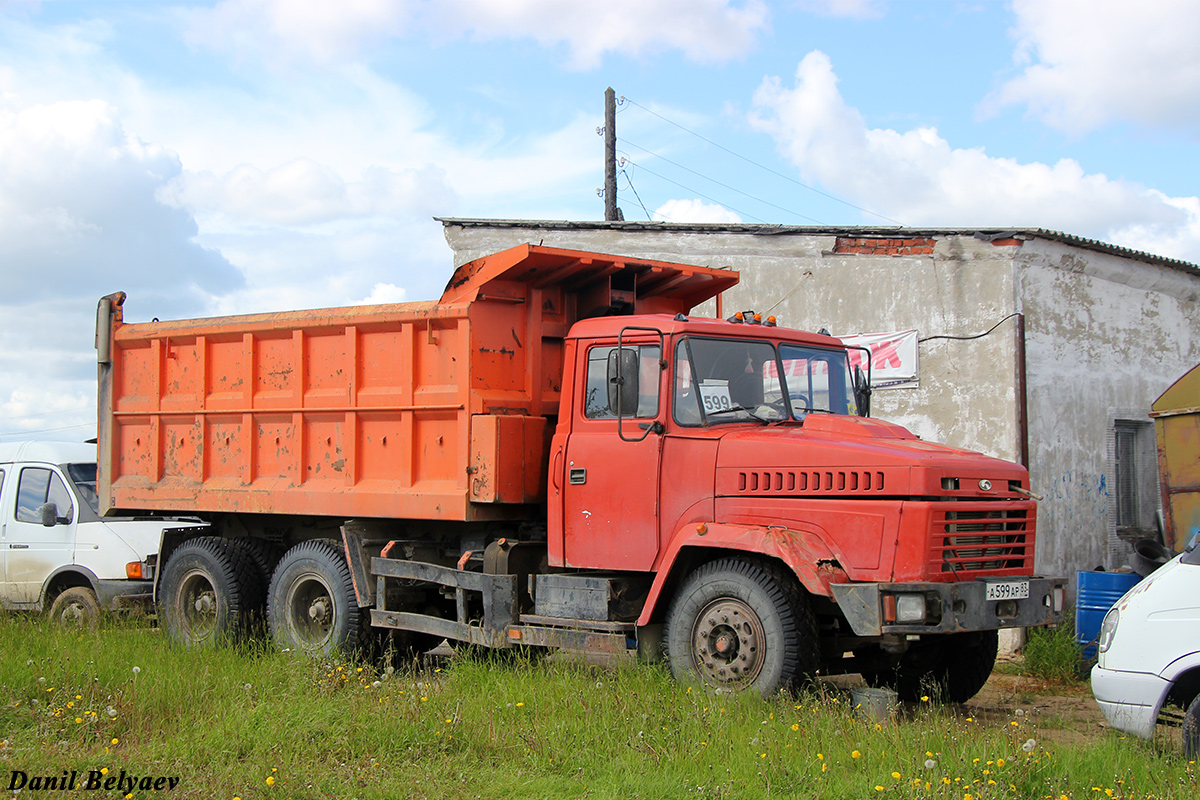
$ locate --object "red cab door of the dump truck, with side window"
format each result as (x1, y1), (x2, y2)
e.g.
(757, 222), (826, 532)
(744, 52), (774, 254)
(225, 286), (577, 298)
(562, 341), (665, 571)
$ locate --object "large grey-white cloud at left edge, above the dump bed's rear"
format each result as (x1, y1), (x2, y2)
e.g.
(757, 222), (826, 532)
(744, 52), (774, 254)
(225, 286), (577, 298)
(0, 98), (241, 309)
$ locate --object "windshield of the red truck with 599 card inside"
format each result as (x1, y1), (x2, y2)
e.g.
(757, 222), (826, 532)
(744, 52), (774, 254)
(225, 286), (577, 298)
(673, 337), (858, 426)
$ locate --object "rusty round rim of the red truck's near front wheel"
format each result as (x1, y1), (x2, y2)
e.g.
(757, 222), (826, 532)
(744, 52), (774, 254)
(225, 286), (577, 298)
(691, 597), (767, 686)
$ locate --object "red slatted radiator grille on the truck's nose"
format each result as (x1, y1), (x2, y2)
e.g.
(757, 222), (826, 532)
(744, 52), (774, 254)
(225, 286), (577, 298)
(930, 509), (1034, 577)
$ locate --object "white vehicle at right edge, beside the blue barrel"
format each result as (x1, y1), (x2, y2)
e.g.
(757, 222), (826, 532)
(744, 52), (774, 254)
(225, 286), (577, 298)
(1092, 543), (1200, 757)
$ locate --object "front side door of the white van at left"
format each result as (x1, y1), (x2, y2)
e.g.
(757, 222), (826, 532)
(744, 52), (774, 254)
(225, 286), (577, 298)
(5, 467), (76, 603)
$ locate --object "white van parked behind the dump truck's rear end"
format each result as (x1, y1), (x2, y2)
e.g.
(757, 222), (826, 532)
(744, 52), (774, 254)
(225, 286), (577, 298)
(0, 441), (199, 625)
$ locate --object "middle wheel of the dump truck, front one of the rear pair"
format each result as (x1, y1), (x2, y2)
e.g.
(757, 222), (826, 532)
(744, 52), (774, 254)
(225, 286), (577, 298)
(266, 539), (373, 655)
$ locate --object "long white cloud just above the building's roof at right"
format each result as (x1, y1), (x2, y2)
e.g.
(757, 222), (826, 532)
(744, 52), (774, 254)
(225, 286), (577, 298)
(751, 50), (1200, 260)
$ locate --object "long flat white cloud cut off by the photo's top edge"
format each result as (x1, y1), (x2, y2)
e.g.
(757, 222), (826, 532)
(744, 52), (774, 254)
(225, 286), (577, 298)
(188, 0), (768, 70)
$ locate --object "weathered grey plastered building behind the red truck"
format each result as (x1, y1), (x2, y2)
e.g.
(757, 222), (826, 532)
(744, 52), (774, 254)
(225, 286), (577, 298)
(442, 218), (1200, 587)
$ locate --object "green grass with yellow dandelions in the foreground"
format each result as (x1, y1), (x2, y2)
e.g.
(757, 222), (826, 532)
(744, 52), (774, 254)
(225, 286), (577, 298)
(0, 616), (1200, 800)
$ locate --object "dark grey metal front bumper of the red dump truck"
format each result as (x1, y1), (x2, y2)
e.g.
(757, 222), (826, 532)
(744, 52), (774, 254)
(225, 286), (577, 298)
(829, 577), (1067, 636)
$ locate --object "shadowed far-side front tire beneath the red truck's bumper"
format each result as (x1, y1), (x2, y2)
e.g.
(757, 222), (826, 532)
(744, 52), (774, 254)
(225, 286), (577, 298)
(863, 630), (1000, 703)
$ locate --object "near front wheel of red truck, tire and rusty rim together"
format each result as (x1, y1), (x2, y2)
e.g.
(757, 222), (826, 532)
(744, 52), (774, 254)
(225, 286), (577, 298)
(664, 558), (817, 697)
